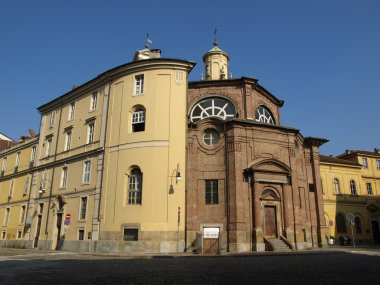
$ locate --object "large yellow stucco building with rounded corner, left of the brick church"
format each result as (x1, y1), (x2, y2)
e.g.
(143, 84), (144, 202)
(0, 48), (195, 252)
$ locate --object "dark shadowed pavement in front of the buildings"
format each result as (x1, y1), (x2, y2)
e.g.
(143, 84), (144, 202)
(0, 247), (380, 285)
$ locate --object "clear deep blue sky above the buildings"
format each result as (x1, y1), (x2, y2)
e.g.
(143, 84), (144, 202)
(0, 0), (380, 155)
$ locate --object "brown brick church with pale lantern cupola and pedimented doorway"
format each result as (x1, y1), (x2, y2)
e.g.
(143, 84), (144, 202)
(186, 40), (327, 253)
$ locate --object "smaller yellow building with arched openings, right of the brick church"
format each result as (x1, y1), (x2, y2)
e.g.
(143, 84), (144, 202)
(320, 149), (380, 243)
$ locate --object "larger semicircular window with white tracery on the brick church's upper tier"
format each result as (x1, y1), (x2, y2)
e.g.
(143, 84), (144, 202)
(190, 98), (236, 123)
